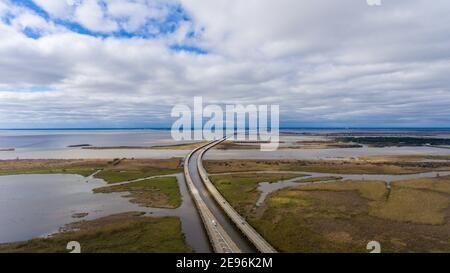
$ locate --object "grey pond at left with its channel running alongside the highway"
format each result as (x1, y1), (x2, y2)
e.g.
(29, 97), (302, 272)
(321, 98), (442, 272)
(0, 174), (210, 252)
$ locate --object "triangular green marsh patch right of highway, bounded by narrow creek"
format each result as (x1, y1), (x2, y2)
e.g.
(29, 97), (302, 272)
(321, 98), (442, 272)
(210, 173), (304, 214)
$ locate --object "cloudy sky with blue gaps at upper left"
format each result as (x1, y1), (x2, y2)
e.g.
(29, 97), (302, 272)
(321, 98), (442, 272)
(0, 0), (450, 128)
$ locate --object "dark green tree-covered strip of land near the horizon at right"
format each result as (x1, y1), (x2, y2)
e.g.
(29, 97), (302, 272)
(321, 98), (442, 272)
(336, 136), (450, 147)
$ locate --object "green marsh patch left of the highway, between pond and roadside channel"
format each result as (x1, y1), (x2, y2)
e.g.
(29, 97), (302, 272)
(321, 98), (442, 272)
(94, 177), (181, 208)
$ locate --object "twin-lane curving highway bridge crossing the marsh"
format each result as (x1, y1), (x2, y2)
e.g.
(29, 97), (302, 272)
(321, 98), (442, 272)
(184, 139), (276, 253)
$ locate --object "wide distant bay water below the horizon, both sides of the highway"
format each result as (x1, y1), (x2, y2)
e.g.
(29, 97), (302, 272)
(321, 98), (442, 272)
(0, 130), (450, 160)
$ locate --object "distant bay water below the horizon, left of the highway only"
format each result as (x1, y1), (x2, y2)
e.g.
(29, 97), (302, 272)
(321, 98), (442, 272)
(0, 130), (189, 160)
